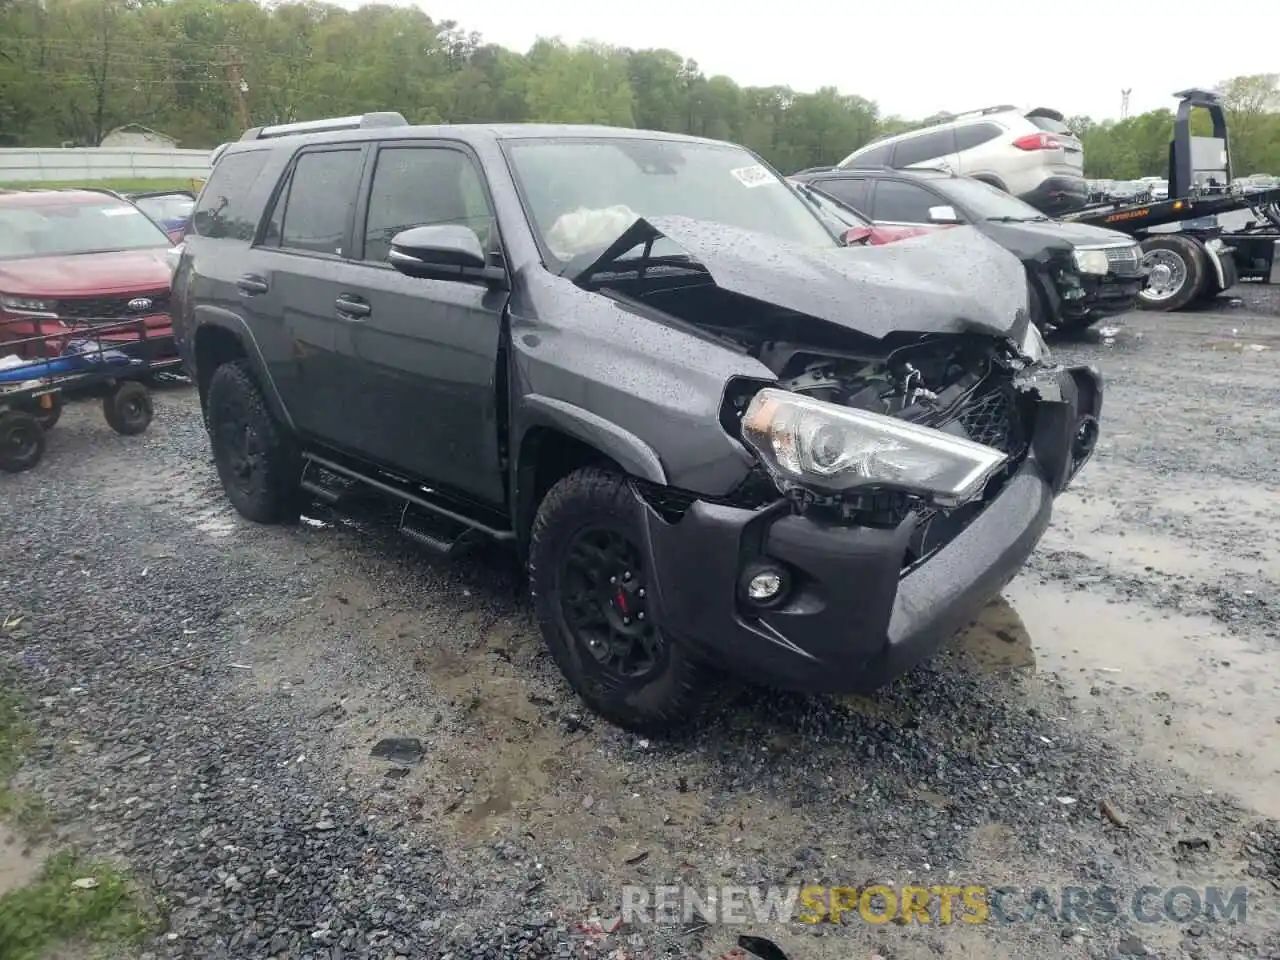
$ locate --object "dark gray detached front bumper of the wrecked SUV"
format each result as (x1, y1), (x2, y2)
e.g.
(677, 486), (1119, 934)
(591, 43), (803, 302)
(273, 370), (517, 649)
(636, 367), (1102, 692)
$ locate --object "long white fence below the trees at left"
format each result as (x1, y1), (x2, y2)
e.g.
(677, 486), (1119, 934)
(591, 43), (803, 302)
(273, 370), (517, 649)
(0, 147), (210, 183)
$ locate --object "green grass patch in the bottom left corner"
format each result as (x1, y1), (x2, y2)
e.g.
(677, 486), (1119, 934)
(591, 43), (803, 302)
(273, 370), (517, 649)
(0, 852), (151, 960)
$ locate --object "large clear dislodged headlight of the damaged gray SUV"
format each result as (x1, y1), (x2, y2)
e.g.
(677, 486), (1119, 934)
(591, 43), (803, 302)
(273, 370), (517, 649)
(742, 388), (1007, 506)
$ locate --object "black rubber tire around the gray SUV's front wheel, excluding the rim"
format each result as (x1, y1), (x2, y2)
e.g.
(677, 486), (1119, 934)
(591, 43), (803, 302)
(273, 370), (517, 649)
(529, 467), (719, 736)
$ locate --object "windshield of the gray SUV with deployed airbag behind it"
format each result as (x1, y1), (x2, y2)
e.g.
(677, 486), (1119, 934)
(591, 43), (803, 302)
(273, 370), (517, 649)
(506, 137), (837, 264)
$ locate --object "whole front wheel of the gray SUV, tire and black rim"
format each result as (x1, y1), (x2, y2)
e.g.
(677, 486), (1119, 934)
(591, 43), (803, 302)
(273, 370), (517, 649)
(529, 467), (718, 735)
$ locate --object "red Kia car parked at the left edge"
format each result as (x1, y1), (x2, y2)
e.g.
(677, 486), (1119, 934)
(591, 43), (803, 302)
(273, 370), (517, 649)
(0, 189), (177, 361)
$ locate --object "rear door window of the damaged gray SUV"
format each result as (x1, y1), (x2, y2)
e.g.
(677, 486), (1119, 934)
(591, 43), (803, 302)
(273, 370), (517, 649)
(271, 147), (364, 256)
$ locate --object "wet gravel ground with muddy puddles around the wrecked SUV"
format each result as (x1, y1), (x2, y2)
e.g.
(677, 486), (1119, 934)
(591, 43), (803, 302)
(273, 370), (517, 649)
(0, 288), (1280, 960)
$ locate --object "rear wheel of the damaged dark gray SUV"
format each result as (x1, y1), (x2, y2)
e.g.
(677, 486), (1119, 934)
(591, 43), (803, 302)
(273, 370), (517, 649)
(205, 360), (301, 524)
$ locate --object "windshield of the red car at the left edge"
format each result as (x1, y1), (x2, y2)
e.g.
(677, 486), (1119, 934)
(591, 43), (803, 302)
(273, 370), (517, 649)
(0, 200), (169, 260)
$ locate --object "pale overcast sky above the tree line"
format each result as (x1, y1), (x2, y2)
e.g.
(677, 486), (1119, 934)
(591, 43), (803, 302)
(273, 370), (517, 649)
(325, 0), (1280, 118)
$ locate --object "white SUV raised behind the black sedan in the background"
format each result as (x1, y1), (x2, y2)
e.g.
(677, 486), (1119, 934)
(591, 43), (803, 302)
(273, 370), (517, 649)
(840, 106), (1089, 215)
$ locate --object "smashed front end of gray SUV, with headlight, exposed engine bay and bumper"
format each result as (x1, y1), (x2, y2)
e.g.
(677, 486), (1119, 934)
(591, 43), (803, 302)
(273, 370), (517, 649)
(619, 300), (1102, 692)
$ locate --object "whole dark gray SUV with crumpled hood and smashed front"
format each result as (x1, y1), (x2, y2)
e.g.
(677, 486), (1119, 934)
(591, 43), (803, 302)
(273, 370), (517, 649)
(173, 108), (1102, 732)
